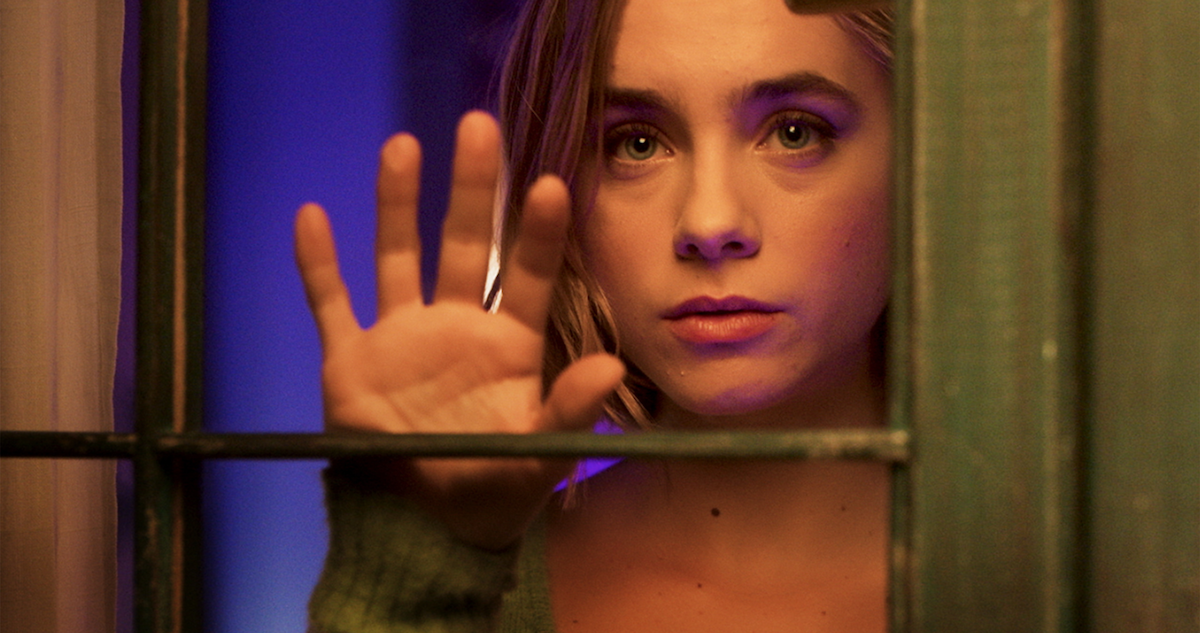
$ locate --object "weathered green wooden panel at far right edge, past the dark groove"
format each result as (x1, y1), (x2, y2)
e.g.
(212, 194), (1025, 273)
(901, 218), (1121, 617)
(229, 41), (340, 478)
(1087, 0), (1200, 633)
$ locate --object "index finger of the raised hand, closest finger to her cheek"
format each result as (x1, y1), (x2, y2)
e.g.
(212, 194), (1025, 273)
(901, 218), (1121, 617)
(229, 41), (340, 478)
(500, 176), (570, 333)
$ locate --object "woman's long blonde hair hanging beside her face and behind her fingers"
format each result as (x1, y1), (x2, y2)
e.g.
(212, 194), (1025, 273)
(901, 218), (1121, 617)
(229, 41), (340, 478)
(490, 0), (893, 428)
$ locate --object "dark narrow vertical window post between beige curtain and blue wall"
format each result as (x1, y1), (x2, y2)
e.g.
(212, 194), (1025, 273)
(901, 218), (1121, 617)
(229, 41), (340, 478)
(133, 0), (208, 633)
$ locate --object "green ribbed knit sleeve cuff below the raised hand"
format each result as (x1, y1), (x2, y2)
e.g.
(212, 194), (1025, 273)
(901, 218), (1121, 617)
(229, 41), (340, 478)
(308, 472), (518, 633)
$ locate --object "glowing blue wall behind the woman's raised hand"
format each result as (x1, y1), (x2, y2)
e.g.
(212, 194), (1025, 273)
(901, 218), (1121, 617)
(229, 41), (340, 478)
(204, 0), (520, 633)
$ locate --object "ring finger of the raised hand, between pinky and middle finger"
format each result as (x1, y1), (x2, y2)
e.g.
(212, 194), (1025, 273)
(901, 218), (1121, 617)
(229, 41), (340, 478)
(376, 134), (421, 318)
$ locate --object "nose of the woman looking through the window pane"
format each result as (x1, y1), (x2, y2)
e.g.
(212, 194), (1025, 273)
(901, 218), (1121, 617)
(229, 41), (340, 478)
(674, 163), (762, 263)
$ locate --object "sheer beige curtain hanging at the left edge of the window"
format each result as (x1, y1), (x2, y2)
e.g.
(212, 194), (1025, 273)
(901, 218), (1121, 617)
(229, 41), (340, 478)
(0, 0), (124, 633)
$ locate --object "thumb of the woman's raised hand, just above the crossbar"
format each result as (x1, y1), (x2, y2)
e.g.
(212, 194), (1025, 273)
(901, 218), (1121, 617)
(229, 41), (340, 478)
(544, 354), (625, 430)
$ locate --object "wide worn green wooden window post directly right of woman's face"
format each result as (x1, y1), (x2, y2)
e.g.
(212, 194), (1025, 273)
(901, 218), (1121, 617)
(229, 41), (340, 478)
(896, 0), (1082, 633)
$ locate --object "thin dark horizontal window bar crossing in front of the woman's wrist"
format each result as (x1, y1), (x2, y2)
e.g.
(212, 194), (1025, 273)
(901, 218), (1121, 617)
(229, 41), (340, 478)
(0, 429), (910, 463)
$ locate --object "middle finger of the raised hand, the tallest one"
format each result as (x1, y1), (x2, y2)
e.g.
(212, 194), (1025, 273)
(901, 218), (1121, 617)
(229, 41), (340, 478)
(436, 111), (500, 305)
